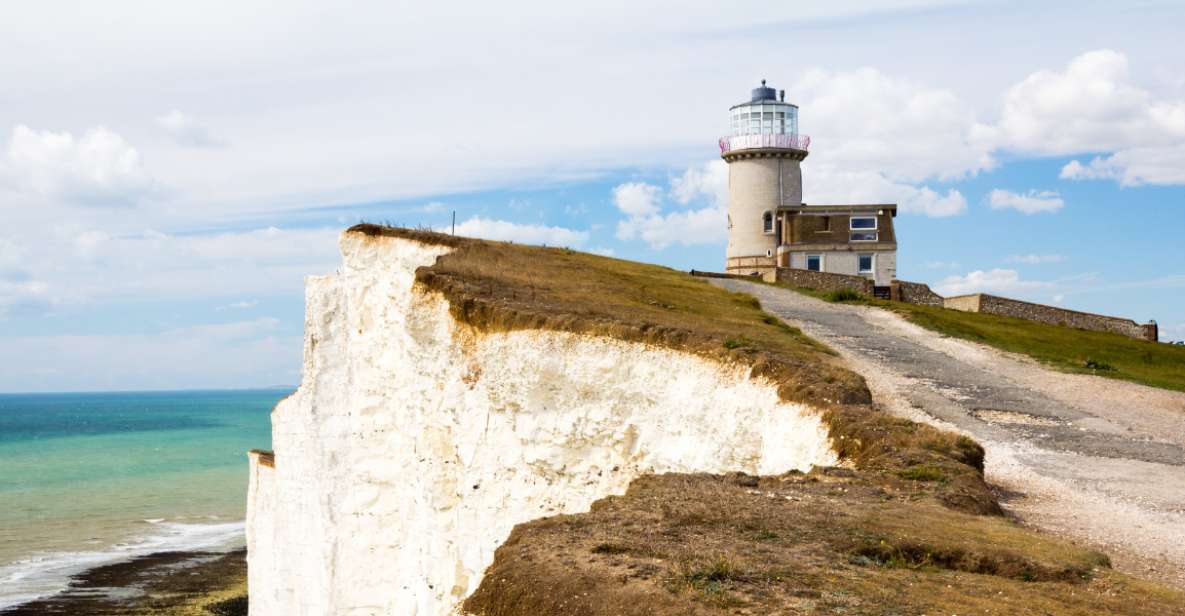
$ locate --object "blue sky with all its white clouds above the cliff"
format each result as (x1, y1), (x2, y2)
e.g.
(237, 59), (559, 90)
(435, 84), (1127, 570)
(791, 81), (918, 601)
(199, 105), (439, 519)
(0, 0), (1185, 392)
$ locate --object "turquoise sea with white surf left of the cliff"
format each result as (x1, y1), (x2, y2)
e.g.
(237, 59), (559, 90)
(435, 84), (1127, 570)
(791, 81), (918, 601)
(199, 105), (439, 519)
(0, 389), (284, 609)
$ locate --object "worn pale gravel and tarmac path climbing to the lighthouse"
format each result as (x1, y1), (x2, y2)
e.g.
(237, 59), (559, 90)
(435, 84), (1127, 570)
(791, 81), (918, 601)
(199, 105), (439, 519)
(712, 280), (1185, 588)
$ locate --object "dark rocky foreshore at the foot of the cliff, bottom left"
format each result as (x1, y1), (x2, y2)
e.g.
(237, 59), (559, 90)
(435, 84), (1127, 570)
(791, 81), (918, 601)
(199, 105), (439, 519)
(0, 548), (246, 616)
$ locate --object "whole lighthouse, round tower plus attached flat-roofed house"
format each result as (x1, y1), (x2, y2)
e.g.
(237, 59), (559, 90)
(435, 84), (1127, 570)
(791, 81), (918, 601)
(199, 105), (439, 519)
(719, 79), (897, 289)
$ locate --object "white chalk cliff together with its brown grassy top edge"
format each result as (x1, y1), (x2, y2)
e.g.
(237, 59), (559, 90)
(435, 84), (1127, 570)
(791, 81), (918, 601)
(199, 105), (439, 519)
(248, 225), (1180, 615)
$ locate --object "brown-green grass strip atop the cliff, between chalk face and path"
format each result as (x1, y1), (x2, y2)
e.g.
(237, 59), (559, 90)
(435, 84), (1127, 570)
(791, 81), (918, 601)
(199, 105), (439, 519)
(351, 225), (870, 406)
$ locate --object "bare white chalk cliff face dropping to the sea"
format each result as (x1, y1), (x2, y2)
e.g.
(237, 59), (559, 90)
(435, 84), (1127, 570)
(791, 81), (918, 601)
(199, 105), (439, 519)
(246, 232), (837, 616)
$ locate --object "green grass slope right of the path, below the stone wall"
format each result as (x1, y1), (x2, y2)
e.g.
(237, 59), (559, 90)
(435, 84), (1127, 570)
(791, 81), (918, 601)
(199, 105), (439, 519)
(794, 283), (1185, 391)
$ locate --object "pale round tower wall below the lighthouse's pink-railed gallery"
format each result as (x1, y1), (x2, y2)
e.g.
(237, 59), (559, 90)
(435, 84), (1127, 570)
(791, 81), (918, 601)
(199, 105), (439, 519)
(728, 156), (802, 262)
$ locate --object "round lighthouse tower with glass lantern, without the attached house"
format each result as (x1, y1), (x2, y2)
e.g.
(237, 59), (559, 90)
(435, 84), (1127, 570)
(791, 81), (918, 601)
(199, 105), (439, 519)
(720, 79), (811, 275)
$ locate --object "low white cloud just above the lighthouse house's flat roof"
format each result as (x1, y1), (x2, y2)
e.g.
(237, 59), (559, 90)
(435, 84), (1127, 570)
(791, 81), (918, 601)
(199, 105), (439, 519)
(802, 166), (967, 218)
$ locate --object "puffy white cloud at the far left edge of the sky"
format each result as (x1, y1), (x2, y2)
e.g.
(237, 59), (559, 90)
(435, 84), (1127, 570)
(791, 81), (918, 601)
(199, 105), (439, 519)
(0, 126), (156, 206)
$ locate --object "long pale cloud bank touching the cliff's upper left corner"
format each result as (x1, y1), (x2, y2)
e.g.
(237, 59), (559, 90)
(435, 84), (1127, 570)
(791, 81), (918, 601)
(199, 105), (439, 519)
(0, 226), (340, 312)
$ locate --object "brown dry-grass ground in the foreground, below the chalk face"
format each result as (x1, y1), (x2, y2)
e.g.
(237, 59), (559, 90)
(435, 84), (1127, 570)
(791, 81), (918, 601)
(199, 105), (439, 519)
(463, 469), (1185, 616)
